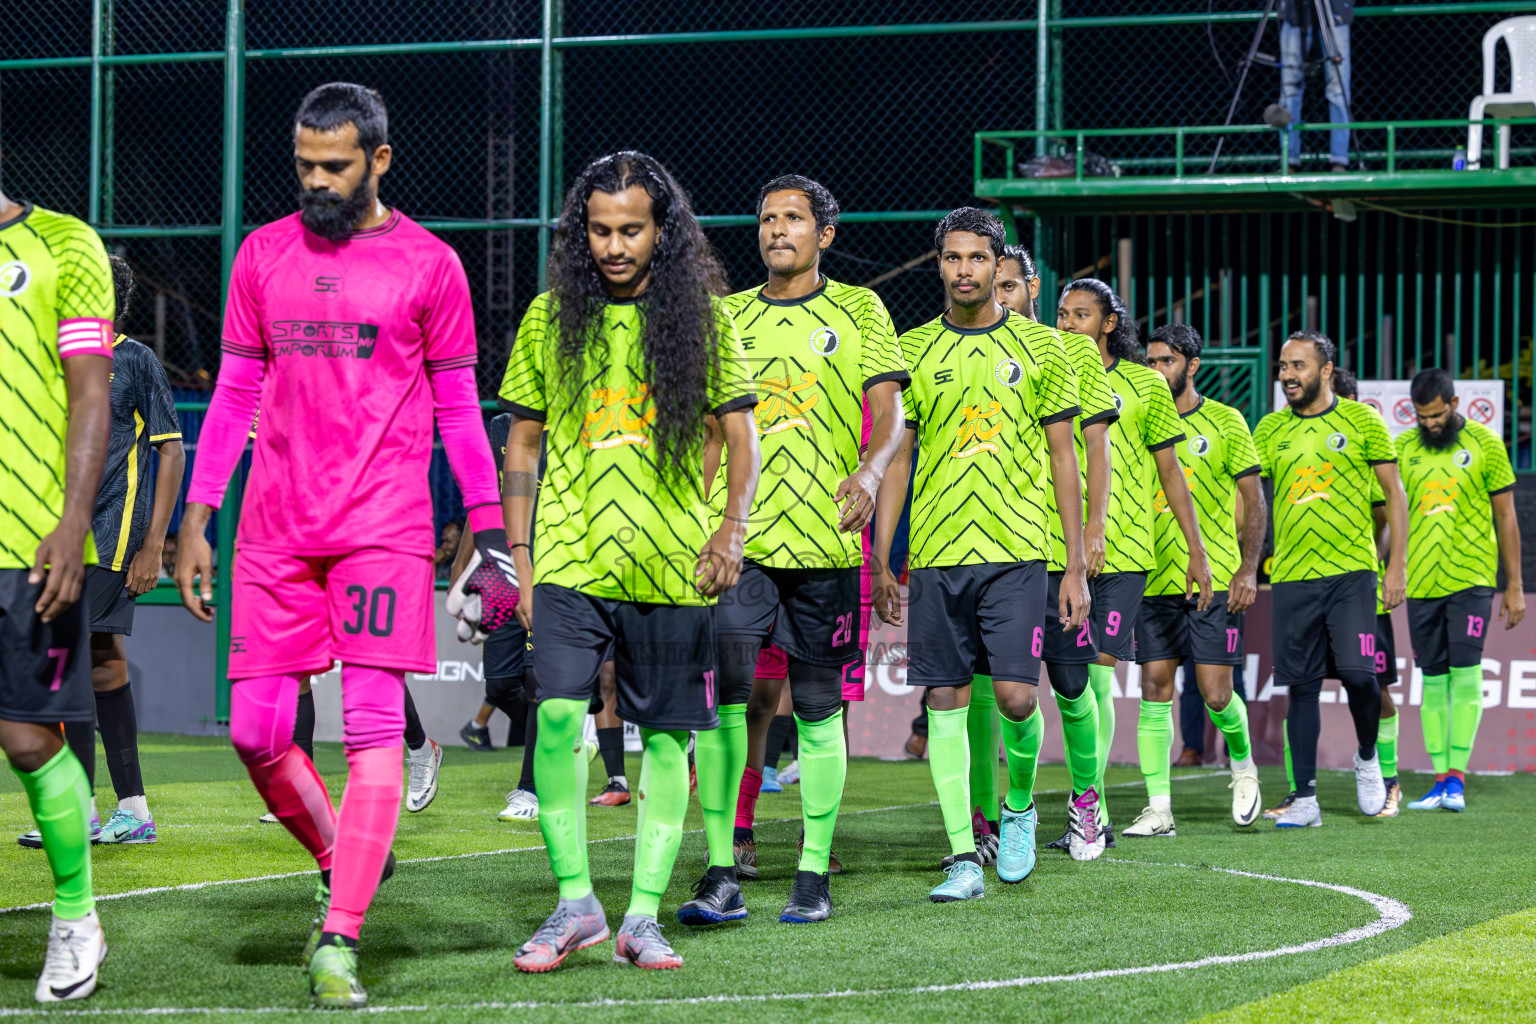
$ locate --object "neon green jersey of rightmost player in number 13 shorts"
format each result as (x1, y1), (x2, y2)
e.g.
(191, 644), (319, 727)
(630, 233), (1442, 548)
(1396, 421), (1514, 597)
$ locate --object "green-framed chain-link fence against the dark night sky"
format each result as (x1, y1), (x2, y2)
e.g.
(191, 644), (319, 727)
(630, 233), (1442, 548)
(0, 0), (1536, 395)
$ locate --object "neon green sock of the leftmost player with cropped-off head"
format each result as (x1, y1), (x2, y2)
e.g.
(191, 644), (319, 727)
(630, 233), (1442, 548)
(11, 746), (95, 920)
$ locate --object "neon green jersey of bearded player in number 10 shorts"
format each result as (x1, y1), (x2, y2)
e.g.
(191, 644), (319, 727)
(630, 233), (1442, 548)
(1253, 399), (1396, 583)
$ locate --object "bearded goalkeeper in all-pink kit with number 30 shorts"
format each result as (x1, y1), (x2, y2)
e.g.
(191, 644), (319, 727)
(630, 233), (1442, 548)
(177, 83), (518, 1007)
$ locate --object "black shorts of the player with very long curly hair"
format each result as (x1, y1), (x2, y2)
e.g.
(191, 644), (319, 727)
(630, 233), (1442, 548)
(533, 583), (720, 731)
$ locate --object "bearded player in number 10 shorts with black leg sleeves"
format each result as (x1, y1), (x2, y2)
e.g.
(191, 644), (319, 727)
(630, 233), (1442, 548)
(1253, 330), (1409, 829)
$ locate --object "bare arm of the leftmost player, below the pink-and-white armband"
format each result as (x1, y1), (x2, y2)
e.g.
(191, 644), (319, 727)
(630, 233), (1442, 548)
(26, 356), (112, 622)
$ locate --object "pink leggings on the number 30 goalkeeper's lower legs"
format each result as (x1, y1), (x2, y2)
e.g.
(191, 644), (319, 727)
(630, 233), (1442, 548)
(229, 665), (406, 940)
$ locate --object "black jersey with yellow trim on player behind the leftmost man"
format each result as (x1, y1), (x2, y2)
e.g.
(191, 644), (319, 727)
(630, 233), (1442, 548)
(91, 335), (181, 570)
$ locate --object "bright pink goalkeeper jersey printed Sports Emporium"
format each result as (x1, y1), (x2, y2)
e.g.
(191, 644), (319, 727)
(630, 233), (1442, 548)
(207, 210), (476, 554)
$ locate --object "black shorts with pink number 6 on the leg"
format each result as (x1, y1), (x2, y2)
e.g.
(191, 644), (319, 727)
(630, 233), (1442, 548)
(906, 562), (1046, 686)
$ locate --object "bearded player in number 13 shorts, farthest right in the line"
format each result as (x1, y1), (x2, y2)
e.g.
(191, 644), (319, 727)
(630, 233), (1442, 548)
(1396, 368), (1525, 811)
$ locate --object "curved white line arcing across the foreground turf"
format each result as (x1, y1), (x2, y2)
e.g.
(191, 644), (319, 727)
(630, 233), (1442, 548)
(0, 858), (1413, 1018)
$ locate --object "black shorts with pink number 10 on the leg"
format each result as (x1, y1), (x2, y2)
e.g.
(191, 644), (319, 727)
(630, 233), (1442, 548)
(1270, 570), (1376, 686)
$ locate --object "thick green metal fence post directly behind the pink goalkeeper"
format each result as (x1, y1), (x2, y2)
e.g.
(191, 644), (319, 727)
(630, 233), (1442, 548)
(214, 0), (246, 722)
